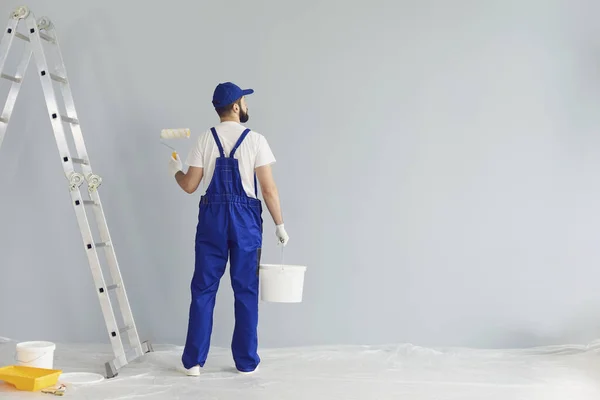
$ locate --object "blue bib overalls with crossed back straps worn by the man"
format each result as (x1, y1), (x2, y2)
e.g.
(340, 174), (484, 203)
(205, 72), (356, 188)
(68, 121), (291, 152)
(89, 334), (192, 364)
(182, 128), (263, 372)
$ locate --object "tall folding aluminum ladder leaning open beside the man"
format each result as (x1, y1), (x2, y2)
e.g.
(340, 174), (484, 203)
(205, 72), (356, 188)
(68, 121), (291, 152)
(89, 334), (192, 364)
(0, 6), (153, 378)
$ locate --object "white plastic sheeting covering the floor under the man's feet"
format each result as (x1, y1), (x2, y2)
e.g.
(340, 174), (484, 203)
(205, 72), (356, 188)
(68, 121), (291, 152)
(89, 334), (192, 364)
(0, 339), (600, 400)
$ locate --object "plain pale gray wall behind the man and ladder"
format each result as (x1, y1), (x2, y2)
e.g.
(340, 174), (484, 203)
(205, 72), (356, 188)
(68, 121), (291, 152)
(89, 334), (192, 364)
(0, 0), (600, 347)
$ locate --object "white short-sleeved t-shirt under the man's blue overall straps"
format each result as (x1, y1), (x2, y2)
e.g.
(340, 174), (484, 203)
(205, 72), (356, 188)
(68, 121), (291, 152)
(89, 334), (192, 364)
(186, 121), (275, 198)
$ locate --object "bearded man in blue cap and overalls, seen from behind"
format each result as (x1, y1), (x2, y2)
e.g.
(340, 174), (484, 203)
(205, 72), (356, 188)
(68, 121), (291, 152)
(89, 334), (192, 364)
(169, 82), (289, 376)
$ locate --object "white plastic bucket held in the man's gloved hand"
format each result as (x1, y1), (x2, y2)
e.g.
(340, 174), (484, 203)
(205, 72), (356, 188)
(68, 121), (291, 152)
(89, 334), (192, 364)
(259, 264), (306, 303)
